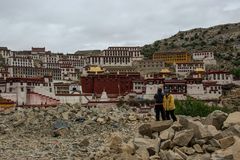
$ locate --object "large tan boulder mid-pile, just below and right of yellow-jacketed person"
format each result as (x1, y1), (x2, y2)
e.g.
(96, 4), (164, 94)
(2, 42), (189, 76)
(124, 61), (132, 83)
(173, 129), (194, 146)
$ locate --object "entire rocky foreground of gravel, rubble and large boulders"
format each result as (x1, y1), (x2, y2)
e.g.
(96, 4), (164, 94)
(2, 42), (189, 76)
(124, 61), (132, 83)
(0, 105), (240, 160)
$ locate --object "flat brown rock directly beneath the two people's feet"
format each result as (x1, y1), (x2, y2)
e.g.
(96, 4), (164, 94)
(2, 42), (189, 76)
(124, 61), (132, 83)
(150, 120), (173, 132)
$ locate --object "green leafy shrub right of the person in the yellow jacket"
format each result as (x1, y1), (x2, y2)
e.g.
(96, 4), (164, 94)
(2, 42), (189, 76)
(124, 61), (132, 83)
(175, 98), (230, 117)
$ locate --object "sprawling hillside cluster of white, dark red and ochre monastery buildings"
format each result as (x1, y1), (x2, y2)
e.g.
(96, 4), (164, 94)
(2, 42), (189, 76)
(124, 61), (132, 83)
(0, 46), (233, 109)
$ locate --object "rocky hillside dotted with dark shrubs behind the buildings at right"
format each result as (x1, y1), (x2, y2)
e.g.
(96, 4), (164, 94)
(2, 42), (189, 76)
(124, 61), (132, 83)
(142, 23), (240, 67)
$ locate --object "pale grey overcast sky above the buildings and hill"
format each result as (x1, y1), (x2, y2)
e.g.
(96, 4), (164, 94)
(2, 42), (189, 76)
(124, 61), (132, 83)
(0, 0), (240, 53)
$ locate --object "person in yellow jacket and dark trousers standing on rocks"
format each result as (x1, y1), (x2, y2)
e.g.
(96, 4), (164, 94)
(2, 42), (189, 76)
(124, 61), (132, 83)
(163, 89), (177, 121)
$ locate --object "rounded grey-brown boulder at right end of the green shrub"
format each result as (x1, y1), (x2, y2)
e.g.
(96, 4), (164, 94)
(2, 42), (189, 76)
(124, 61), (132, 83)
(204, 110), (228, 130)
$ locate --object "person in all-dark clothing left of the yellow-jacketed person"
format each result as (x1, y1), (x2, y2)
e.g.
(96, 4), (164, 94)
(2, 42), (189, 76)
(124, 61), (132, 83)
(154, 88), (166, 121)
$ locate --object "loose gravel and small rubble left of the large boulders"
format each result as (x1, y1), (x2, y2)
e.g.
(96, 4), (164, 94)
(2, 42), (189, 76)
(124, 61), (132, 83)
(0, 104), (153, 159)
